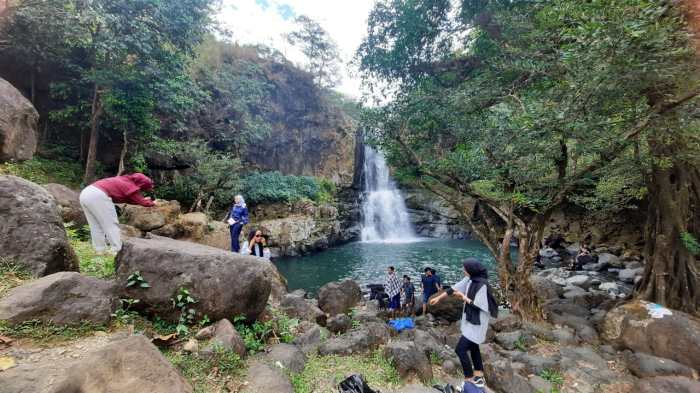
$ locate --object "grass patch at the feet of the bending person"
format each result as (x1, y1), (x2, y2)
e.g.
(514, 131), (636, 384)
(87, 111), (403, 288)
(65, 223), (115, 278)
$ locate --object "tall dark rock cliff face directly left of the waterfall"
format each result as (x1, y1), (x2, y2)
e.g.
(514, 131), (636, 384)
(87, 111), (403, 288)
(247, 63), (356, 187)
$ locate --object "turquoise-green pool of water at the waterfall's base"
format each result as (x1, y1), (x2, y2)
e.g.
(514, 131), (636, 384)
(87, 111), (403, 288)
(274, 239), (495, 294)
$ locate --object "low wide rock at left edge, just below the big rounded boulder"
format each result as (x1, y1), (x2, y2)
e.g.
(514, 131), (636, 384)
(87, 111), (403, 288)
(0, 272), (118, 325)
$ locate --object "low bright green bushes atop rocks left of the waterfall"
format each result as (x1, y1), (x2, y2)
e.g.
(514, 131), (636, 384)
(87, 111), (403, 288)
(242, 171), (322, 203)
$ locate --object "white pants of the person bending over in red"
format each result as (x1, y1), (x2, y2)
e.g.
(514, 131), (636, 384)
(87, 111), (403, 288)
(80, 186), (122, 252)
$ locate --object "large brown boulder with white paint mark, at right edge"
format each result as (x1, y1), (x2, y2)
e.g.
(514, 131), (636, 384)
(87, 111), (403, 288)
(601, 301), (700, 369)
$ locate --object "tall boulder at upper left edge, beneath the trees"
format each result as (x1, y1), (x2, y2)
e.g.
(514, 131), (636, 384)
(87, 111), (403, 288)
(0, 78), (39, 162)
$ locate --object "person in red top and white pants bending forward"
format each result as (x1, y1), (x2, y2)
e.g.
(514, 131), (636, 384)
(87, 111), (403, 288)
(80, 173), (155, 253)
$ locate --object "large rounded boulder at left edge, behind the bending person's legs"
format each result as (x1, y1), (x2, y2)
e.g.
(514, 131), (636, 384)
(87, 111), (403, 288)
(0, 176), (78, 276)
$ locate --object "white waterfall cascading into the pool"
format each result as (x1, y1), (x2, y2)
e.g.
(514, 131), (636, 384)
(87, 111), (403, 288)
(361, 146), (416, 243)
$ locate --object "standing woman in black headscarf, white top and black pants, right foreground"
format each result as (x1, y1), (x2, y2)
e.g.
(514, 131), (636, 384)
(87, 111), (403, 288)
(430, 258), (498, 391)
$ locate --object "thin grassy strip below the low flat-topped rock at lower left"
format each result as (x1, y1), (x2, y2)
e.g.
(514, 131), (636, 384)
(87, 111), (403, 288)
(0, 320), (105, 344)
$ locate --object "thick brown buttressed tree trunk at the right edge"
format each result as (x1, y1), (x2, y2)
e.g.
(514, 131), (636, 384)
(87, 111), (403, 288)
(637, 149), (700, 314)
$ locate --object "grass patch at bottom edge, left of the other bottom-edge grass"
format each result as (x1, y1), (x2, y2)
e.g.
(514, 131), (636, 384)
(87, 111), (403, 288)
(163, 347), (243, 393)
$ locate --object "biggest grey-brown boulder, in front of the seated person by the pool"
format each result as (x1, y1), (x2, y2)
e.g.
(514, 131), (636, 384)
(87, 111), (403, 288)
(116, 236), (275, 321)
